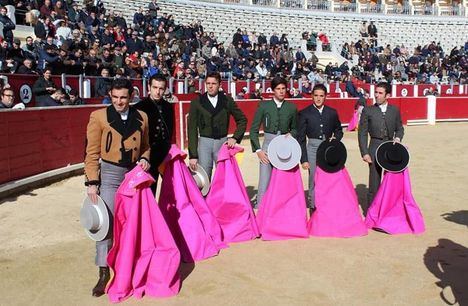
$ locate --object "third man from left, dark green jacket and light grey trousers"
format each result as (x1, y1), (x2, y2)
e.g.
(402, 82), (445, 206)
(188, 72), (247, 178)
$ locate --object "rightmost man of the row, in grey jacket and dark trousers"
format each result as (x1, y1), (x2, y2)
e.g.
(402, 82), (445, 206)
(358, 82), (404, 205)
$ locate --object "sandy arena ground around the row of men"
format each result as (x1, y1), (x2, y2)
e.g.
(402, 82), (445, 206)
(0, 123), (468, 305)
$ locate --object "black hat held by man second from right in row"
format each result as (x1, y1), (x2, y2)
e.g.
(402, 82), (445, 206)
(317, 139), (347, 173)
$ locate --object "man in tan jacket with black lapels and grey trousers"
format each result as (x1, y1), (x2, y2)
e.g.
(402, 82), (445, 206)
(85, 79), (150, 297)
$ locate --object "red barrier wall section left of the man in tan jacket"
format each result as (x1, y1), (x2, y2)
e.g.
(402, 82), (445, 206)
(0, 106), (102, 184)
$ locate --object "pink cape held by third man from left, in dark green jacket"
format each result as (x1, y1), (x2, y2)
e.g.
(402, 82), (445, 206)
(206, 145), (259, 243)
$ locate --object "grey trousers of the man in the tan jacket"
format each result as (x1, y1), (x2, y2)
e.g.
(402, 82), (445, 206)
(95, 161), (128, 267)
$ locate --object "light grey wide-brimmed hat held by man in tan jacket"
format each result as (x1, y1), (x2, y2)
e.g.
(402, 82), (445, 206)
(80, 196), (110, 241)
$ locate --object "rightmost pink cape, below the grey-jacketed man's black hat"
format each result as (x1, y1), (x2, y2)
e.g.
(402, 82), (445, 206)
(366, 169), (425, 234)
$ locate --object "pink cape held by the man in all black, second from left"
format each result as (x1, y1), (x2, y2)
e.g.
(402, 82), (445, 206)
(159, 145), (227, 262)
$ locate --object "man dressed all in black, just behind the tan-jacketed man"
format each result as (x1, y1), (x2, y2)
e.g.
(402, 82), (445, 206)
(135, 74), (174, 194)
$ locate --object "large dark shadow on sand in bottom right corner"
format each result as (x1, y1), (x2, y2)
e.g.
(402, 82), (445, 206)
(424, 239), (468, 306)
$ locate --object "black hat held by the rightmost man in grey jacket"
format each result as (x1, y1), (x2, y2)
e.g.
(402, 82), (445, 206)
(375, 140), (409, 172)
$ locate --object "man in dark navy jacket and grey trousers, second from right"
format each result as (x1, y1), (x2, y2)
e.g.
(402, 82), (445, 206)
(297, 84), (343, 211)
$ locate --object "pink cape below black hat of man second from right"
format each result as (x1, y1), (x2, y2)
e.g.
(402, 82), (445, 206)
(308, 167), (367, 237)
